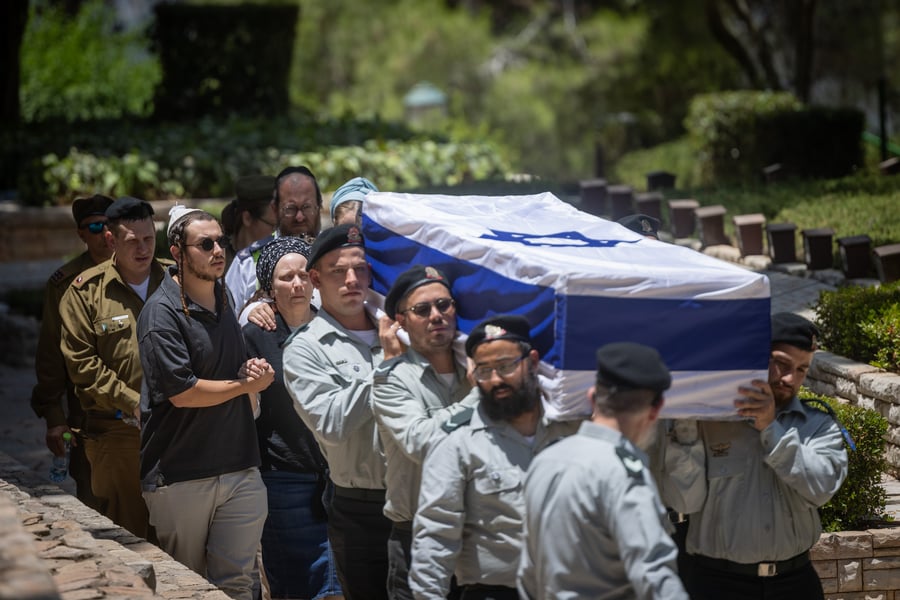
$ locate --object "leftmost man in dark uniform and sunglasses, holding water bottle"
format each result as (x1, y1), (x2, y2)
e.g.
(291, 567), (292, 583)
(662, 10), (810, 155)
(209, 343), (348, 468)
(31, 194), (113, 512)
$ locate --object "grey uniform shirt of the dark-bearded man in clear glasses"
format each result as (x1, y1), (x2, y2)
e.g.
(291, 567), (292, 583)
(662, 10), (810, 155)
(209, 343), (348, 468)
(409, 396), (578, 599)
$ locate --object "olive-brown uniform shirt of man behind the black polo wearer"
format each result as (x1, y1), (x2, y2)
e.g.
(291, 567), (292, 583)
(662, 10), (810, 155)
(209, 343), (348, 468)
(59, 256), (164, 416)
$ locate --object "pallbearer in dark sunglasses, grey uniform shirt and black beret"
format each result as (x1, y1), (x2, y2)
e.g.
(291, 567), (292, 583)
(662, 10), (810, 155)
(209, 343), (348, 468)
(372, 265), (478, 600)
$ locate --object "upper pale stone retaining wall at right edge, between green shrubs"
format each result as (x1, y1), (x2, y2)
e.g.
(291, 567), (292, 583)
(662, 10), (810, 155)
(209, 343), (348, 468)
(806, 350), (900, 477)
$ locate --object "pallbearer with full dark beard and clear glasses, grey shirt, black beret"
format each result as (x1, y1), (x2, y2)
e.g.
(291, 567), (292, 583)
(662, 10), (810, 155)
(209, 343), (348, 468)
(410, 315), (578, 600)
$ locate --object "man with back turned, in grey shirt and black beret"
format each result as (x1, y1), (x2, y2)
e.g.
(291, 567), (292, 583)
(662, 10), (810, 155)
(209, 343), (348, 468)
(519, 342), (687, 600)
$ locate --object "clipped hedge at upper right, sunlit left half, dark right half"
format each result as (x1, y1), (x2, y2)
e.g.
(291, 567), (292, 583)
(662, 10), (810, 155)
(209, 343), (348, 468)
(685, 92), (865, 183)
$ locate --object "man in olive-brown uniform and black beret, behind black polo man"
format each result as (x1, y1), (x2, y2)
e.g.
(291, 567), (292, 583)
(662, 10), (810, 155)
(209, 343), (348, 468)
(59, 197), (163, 537)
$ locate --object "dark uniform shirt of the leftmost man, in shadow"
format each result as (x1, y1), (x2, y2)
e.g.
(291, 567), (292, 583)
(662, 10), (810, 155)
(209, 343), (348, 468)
(31, 252), (94, 429)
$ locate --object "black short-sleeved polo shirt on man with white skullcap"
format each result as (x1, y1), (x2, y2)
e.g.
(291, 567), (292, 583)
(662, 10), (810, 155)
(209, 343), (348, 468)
(138, 267), (260, 489)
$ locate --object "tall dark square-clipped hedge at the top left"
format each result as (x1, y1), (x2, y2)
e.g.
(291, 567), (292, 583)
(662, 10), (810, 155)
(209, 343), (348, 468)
(151, 3), (299, 120)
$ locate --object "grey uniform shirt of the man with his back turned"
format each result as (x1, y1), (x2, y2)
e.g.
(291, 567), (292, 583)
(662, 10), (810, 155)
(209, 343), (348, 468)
(519, 422), (688, 600)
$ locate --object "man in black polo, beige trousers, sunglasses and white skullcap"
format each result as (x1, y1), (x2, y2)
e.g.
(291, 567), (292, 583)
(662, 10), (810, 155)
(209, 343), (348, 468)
(138, 206), (275, 600)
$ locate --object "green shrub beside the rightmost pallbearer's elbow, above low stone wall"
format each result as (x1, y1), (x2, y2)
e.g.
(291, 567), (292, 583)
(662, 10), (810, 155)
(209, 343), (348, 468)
(800, 390), (888, 531)
